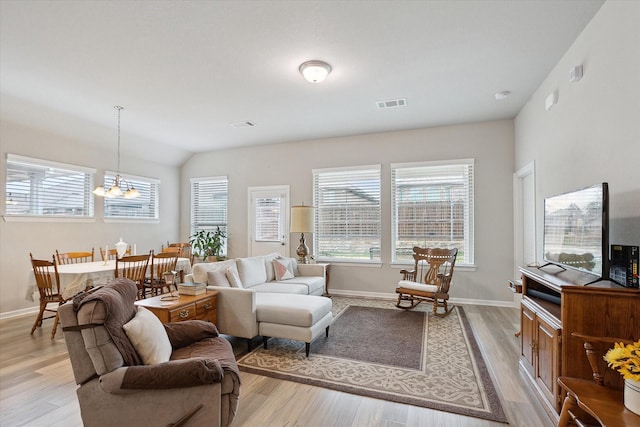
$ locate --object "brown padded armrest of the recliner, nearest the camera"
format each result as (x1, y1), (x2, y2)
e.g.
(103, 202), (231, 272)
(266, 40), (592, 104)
(100, 358), (224, 394)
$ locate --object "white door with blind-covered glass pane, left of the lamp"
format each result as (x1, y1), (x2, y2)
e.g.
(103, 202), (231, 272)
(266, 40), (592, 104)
(247, 185), (289, 256)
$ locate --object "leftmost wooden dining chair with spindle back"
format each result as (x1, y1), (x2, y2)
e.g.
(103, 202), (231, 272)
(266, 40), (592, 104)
(29, 253), (65, 339)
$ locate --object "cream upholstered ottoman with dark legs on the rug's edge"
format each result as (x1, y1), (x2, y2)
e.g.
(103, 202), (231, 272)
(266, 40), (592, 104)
(256, 293), (333, 357)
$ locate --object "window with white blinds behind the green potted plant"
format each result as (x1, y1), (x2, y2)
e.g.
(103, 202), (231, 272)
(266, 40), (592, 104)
(191, 176), (229, 254)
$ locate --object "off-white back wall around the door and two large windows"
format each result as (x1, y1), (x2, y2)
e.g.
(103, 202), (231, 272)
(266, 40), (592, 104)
(181, 120), (514, 303)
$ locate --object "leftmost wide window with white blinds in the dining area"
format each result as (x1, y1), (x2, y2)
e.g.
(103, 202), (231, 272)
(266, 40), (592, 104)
(5, 154), (96, 218)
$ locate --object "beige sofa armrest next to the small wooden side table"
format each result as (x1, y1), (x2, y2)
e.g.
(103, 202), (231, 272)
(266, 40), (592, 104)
(207, 286), (258, 338)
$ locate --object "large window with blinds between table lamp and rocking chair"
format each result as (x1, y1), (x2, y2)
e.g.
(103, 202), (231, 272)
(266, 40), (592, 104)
(313, 165), (381, 261)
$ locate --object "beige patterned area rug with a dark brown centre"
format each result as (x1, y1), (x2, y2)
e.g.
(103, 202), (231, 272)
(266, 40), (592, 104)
(238, 298), (507, 423)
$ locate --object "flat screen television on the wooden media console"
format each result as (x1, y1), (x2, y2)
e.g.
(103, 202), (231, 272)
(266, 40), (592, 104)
(543, 182), (609, 279)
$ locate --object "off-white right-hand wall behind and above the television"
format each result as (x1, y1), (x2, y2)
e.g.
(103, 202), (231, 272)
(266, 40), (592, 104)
(515, 0), (640, 259)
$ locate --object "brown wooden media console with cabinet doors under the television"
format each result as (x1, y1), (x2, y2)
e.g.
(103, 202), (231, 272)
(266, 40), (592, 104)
(520, 265), (640, 421)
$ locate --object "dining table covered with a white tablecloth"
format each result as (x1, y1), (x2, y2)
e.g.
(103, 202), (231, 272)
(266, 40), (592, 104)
(25, 258), (191, 301)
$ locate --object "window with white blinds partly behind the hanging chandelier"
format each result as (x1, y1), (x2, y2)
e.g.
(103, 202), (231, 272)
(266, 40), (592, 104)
(104, 172), (160, 220)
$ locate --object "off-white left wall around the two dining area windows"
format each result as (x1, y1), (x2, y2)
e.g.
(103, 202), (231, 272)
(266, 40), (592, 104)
(0, 120), (180, 316)
